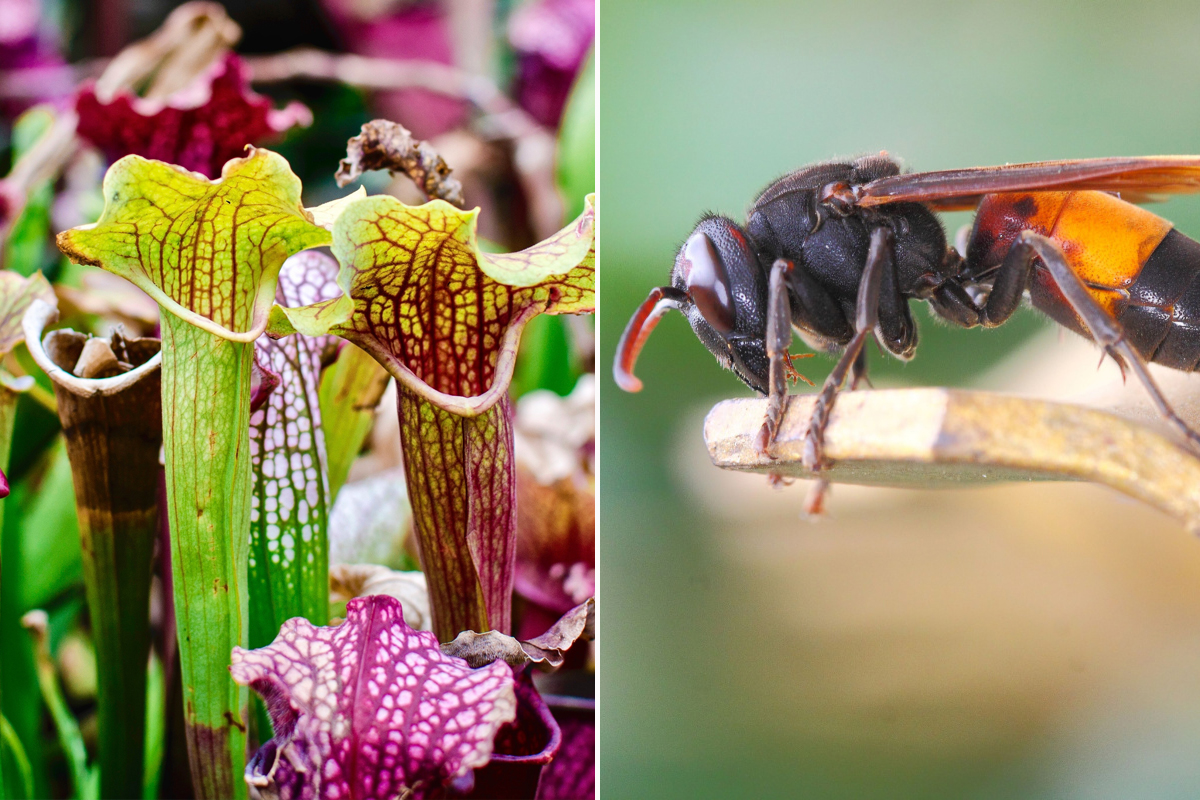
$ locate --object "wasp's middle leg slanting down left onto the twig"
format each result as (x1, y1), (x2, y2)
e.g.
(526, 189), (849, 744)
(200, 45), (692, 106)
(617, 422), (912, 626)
(804, 228), (895, 472)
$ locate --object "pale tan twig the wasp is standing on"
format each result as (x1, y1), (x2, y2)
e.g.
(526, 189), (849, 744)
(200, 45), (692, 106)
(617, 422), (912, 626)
(704, 389), (1200, 531)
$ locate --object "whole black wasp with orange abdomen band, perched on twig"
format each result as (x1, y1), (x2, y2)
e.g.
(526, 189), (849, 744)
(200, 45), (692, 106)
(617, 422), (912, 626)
(613, 152), (1200, 505)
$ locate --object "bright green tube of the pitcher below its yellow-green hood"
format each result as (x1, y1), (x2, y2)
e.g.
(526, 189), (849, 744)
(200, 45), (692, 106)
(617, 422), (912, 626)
(162, 312), (254, 799)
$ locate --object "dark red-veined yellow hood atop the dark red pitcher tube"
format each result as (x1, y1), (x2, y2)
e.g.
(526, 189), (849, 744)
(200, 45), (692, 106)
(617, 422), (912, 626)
(334, 197), (595, 397)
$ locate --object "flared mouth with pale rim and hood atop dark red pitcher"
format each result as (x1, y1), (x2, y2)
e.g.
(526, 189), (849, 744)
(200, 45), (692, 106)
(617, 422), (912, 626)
(266, 197), (595, 417)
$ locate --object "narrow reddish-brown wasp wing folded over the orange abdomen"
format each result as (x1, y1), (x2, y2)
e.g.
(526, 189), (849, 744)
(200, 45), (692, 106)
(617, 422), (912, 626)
(858, 156), (1200, 211)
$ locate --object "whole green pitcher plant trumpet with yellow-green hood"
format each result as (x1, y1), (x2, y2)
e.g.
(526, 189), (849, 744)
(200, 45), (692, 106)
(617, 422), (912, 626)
(58, 148), (329, 798)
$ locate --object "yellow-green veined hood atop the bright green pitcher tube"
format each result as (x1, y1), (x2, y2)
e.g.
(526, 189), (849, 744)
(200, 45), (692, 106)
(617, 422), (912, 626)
(59, 150), (329, 332)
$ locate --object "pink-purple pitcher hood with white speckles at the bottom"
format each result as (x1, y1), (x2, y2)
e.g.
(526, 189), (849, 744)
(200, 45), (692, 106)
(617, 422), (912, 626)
(230, 595), (516, 800)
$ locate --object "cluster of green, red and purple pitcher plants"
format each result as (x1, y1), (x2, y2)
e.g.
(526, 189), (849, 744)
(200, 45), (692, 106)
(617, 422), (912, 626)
(0, 4), (596, 799)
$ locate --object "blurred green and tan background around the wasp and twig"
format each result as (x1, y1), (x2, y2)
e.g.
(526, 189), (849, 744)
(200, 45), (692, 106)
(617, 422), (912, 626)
(599, 0), (1200, 798)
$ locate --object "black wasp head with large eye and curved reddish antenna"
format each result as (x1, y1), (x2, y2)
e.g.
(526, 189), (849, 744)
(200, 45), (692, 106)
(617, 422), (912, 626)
(613, 216), (769, 393)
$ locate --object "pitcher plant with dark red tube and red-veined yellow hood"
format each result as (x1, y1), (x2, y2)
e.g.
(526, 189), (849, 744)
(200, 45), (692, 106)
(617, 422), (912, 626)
(314, 197), (595, 640)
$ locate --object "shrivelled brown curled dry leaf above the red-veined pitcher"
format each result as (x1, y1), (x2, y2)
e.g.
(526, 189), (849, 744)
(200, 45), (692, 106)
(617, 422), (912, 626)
(335, 120), (462, 207)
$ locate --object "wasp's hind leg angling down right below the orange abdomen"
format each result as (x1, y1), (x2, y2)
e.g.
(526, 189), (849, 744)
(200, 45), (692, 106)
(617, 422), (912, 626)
(1017, 230), (1200, 452)
